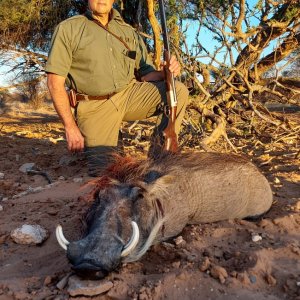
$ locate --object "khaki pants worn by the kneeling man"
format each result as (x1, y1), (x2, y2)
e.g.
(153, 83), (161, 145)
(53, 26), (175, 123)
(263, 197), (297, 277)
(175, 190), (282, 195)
(77, 81), (188, 173)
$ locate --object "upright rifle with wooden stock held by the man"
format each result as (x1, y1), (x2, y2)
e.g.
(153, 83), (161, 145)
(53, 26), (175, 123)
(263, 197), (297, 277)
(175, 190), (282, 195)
(158, 0), (178, 152)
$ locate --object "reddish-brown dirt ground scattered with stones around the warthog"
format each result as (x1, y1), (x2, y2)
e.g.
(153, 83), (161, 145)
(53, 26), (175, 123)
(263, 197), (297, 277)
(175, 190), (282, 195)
(0, 104), (300, 300)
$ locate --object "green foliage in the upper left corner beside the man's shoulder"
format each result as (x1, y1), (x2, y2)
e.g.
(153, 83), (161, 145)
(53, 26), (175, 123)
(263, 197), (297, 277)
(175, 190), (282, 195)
(0, 0), (86, 51)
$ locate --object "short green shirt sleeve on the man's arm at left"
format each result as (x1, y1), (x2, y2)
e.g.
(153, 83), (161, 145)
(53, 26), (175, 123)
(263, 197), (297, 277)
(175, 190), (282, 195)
(45, 25), (72, 78)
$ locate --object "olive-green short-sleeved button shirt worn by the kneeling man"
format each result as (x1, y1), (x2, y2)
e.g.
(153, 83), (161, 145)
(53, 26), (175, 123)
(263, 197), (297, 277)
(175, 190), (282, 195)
(45, 9), (155, 96)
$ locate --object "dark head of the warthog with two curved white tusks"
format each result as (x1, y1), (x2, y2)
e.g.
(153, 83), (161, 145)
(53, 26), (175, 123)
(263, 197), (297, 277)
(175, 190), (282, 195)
(56, 162), (162, 279)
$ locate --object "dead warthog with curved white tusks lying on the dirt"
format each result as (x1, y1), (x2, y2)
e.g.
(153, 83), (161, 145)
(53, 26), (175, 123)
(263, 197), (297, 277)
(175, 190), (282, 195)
(56, 153), (272, 278)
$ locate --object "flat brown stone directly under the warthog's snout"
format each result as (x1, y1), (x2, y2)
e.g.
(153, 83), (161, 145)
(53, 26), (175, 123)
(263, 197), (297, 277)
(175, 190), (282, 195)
(68, 276), (113, 297)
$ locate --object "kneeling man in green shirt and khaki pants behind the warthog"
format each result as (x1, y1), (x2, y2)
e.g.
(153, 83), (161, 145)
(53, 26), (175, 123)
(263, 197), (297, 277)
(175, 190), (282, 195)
(46, 0), (188, 175)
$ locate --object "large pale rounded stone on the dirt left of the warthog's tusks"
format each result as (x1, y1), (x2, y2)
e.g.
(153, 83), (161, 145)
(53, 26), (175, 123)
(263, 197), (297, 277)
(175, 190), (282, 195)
(10, 224), (48, 245)
